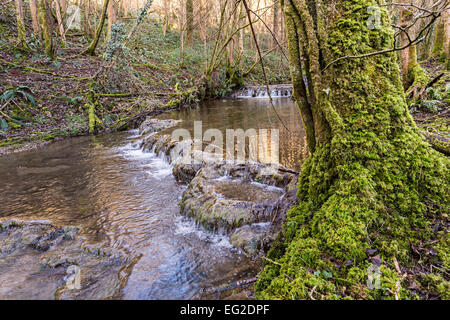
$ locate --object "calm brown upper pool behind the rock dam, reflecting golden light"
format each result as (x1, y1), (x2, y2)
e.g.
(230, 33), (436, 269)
(160, 98), (309, 170)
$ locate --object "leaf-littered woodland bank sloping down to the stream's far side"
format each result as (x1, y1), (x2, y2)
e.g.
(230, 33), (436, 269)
(0, 2), (289, 155)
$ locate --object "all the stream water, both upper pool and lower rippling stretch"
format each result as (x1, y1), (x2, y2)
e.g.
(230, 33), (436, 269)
(0, 99), (307, 299)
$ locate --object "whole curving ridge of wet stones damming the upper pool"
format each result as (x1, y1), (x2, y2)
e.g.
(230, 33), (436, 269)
(137, 117), (297, 257)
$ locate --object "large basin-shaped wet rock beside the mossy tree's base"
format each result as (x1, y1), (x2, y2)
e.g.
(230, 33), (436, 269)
(180, 162), (297, 257)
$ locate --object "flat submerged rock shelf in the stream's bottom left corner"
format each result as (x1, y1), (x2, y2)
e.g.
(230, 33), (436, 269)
(0, 220), (138, 300)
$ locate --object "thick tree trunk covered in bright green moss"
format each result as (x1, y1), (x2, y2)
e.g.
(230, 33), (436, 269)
(256, 0), (450, 299)
